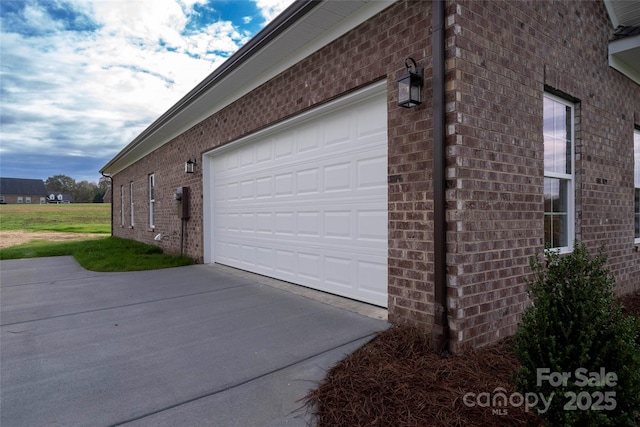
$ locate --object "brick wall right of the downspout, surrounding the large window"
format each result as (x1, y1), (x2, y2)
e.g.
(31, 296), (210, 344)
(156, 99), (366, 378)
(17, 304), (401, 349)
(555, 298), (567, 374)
(447, 0), (640, 347)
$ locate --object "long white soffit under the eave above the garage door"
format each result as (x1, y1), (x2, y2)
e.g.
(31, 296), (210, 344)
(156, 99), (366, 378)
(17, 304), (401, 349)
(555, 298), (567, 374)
(100, 0), (395, 175)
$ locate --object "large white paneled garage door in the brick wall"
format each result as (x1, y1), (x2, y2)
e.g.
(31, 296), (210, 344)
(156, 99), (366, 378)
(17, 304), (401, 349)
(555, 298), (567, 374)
(208, 85), (388, 307)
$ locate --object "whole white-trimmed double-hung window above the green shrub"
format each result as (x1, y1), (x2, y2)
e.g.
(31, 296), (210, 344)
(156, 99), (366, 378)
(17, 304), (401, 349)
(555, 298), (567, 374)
(543, 93), (575, 252)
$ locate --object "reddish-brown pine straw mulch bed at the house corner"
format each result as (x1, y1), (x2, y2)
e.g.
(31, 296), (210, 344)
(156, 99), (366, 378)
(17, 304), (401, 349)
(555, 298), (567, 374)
(305, 292), (640, 427)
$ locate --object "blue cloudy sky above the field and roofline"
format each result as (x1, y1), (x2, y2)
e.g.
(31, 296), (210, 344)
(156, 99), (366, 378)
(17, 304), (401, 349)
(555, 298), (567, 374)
(0, 0), (293, 182)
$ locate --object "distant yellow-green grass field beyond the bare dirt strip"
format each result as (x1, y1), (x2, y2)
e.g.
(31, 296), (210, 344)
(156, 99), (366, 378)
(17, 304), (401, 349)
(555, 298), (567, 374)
(0, 203), (111, 234)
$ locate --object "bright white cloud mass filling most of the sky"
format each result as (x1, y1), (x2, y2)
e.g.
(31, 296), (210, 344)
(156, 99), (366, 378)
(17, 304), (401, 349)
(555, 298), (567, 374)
(2, 0), (235, 155)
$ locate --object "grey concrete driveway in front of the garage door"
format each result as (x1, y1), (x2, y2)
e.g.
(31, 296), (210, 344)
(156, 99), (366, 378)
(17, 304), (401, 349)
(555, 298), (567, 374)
(0, 257), (388, 427)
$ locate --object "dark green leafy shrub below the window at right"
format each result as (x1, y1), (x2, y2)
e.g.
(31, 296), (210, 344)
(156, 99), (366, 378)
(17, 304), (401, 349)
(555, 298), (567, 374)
(514, 243), (640, 426)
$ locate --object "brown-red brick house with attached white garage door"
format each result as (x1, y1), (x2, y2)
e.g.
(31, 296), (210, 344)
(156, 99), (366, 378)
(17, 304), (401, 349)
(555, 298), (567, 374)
(101, 0), (640, 351)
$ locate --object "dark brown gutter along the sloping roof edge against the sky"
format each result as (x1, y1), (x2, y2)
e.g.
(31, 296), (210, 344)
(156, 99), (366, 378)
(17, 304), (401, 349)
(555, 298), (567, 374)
(100, 0), (322, 173)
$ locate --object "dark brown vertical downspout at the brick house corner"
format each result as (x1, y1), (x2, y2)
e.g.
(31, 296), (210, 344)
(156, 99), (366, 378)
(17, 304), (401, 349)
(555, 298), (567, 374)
(431, 0), (449, 353)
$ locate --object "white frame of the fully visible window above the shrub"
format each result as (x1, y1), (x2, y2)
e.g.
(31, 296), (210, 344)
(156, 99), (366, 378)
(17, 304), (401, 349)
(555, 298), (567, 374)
(543, 92), (576, 253)
